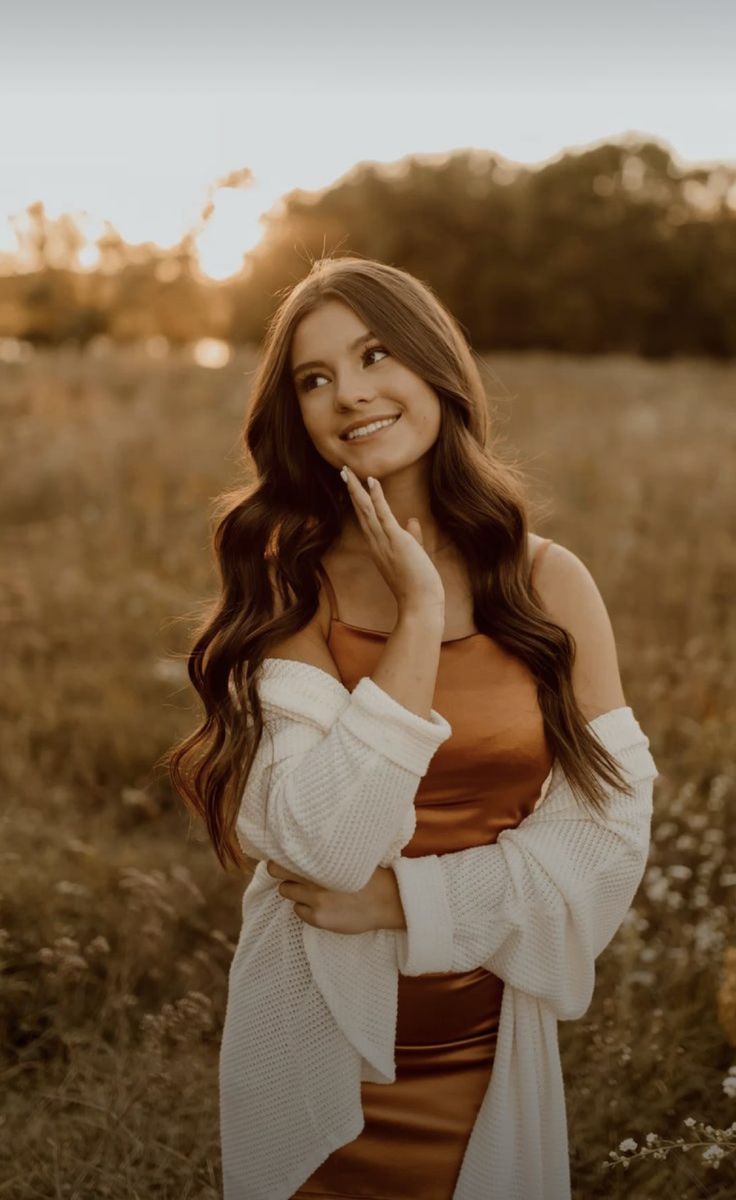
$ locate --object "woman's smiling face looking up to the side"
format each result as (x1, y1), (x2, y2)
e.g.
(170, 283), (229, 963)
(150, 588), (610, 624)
(291, 300), (442, 484)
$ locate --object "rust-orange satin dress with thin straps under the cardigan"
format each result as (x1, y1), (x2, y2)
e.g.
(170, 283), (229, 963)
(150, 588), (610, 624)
(293, 539), (552, 1200)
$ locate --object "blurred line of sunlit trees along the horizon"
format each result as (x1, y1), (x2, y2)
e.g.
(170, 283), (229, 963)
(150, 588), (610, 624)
(0, 139), (736, 359)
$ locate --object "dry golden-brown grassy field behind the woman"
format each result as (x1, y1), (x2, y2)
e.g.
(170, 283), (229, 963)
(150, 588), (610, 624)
(0, 350), (736, 1200)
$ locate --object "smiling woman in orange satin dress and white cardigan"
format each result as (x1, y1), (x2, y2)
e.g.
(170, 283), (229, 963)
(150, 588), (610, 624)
(170, 258), (657, 1200)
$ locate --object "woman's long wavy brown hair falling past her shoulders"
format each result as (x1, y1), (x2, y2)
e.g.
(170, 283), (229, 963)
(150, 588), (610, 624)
(163, 256), (630, 870)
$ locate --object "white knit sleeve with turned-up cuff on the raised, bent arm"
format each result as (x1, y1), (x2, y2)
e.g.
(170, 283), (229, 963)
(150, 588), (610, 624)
(237, 659), (453, 892)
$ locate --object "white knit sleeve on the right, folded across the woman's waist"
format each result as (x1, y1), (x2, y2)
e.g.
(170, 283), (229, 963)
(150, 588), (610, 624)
(391, 707), (658, 1020)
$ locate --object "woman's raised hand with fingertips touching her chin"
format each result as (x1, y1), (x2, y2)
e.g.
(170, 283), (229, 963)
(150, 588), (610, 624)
(336, 467), (444, 616)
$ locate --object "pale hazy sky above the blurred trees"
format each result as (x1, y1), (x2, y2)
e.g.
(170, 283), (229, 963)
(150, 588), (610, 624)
(0, 0), (736, 278)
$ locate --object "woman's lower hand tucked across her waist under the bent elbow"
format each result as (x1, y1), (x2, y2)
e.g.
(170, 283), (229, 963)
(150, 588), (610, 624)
(265, 858), (406, 934)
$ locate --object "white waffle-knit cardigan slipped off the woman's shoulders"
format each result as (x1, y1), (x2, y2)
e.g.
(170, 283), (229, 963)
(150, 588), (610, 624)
(220, 659), (658, 1200)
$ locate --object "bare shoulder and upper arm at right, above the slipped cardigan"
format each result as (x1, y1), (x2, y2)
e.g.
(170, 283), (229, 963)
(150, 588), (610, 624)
(534, 539), (627, 721)
